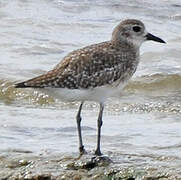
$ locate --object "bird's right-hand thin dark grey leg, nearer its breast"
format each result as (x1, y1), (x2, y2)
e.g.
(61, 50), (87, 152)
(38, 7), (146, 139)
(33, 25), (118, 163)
(95, 103), (104, 156)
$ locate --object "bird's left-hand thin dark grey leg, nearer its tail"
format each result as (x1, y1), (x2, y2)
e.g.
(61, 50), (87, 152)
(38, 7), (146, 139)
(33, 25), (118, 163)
(76, 102), (85, 155)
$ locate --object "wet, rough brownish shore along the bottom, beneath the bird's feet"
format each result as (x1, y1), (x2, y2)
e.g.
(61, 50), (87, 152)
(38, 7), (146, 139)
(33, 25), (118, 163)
(0, 150), (181, 180)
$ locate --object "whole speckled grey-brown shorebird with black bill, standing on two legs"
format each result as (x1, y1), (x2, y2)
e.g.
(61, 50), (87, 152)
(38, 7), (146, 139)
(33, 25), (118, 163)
(15, 19), (165, 155)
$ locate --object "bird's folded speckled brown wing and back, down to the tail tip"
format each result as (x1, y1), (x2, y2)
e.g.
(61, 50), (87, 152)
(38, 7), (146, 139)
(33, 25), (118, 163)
(16, 43), (134, 89)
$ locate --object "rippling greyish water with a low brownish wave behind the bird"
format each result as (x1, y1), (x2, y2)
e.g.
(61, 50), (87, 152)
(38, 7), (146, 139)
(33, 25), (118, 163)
(0, 0), (181, 179)
